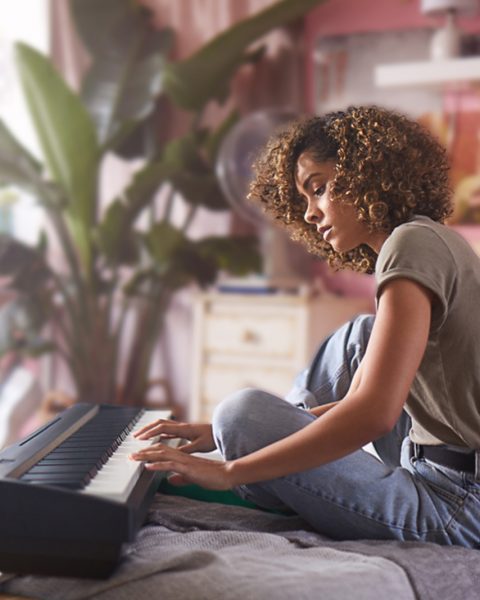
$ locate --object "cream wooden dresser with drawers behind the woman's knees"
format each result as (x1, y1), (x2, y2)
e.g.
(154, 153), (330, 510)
(189, 292), (373, 421)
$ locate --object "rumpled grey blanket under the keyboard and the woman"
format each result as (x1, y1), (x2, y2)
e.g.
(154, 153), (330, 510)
(2, 495), (480, 600)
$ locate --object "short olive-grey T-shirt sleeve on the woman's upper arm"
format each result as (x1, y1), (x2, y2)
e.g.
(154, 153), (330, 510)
(375, 223), (457, 330)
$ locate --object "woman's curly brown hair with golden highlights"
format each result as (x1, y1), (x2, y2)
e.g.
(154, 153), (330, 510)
(248, 106), (452, 273)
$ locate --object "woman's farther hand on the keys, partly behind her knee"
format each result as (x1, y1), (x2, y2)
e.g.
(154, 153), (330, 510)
(133, 419), (216, 454)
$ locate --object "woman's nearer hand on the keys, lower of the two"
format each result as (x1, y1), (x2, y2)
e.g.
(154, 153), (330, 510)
(130, 443), (233, 490)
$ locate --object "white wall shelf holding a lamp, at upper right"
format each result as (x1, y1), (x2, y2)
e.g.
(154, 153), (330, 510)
(374, 56), (480, 87)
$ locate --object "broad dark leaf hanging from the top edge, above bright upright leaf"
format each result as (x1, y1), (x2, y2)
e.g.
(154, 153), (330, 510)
(70, 0), (173, 147)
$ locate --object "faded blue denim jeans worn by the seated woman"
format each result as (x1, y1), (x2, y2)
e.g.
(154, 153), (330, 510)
(212, 315), (480, 548)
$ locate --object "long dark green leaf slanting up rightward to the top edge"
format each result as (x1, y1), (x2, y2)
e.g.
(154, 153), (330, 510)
(164, 0), (325, 111)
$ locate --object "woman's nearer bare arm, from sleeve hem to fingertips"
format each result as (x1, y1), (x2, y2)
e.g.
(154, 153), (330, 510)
(130, 279), (431, 489)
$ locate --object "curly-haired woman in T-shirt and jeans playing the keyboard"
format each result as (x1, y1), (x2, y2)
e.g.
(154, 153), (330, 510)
(133, 107), (480, 547)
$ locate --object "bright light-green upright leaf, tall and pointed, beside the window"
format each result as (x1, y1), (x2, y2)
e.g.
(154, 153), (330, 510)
(16, 43), (99, 265)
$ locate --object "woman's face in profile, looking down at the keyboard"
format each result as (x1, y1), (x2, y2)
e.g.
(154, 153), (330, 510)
(295, 151), (387, 253)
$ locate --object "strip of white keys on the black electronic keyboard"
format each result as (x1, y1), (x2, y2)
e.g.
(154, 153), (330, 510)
(82, 410), (172, 502)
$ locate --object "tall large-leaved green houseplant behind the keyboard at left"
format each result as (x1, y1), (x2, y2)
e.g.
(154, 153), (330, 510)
(0, 0), (319, 404)
